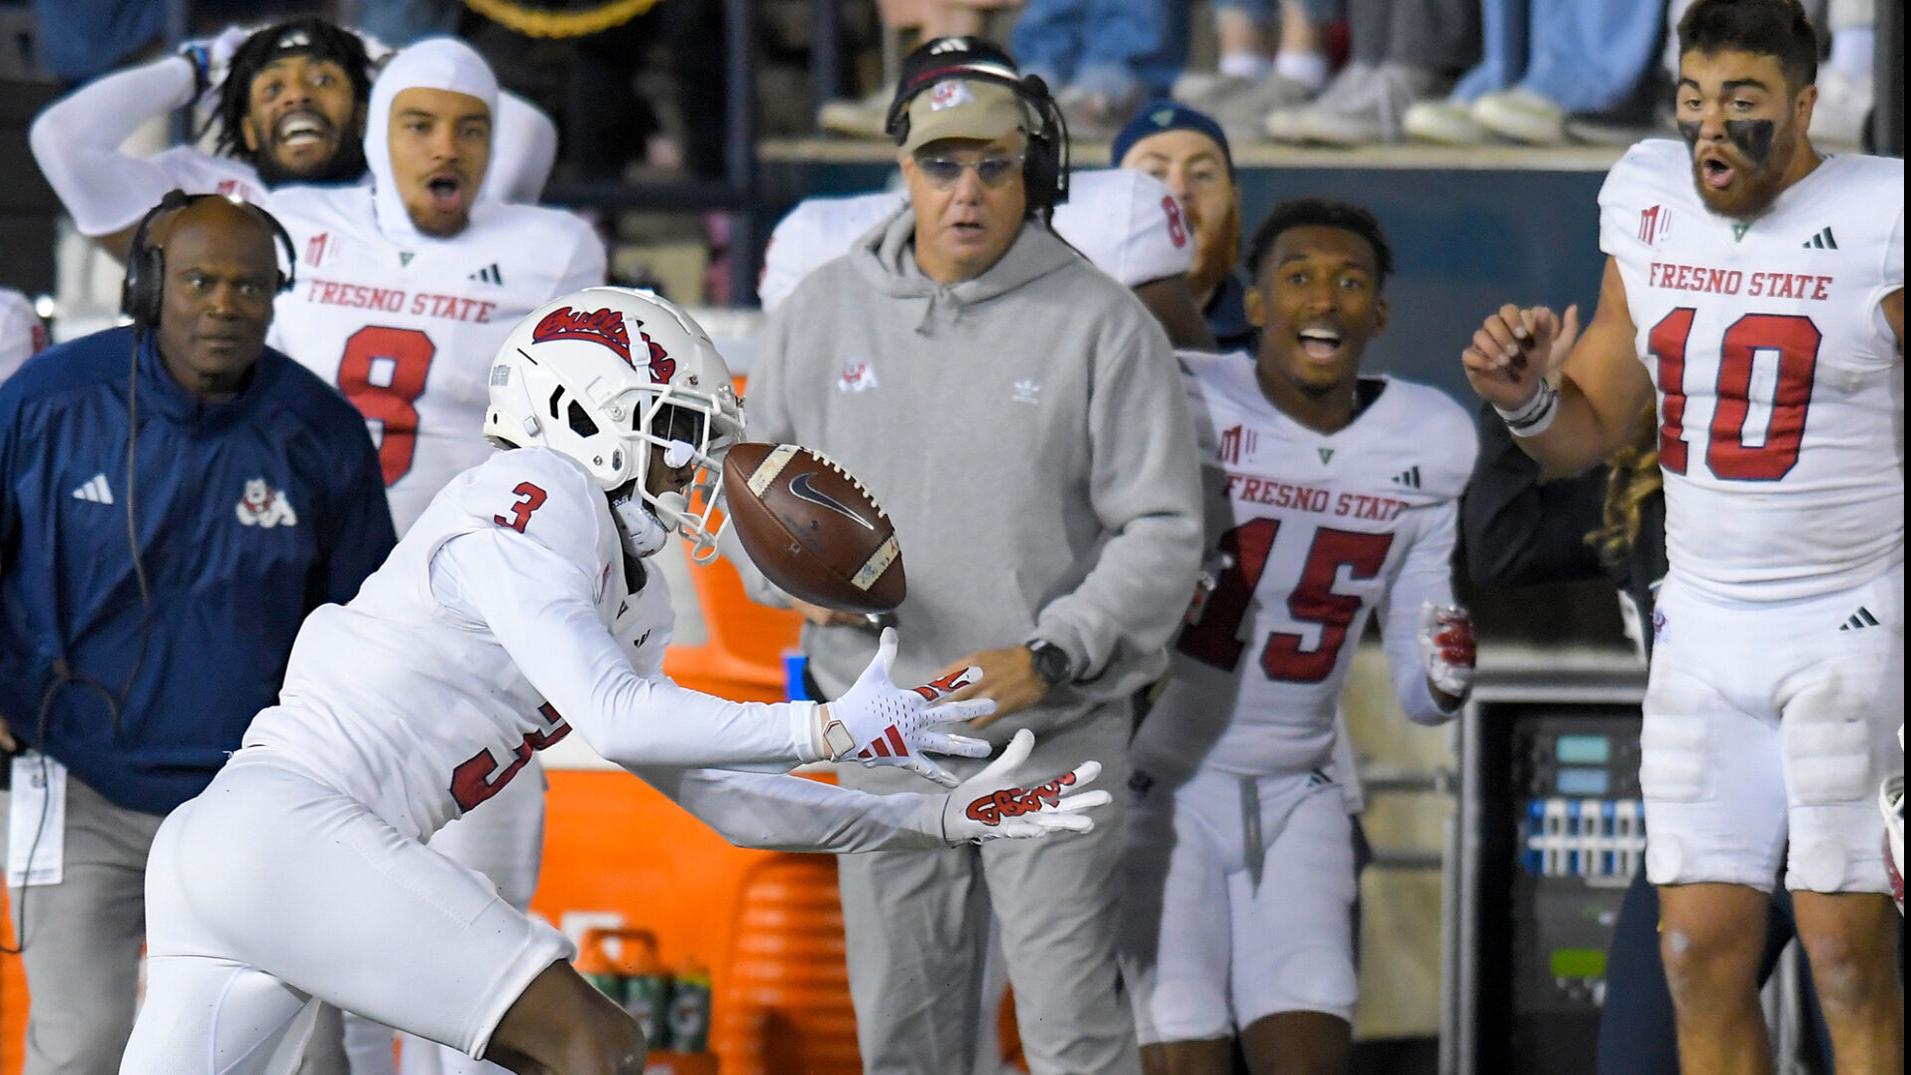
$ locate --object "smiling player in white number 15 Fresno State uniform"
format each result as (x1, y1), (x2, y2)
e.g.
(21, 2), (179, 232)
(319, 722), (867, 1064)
(1122, 199), (1477, 1075)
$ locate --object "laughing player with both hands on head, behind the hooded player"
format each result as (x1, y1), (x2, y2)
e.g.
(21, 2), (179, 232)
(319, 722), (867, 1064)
(31, 15), (558, 258)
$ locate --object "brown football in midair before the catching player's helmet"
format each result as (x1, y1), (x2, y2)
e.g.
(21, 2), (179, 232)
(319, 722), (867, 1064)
(722, 441), (908, 613)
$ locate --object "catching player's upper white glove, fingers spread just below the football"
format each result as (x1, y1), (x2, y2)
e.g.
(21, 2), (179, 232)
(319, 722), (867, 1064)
(816, 626), (996, 787)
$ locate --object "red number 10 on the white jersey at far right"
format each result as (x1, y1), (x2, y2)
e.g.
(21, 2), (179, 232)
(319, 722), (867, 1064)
(1645, 306), (1823, 481)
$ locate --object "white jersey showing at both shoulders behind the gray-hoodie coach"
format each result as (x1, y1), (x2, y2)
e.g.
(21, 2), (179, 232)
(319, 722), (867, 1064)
(757, 168), (1194, 313)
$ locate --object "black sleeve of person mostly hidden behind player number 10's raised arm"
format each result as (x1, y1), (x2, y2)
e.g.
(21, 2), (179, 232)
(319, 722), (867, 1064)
(1460, 405), (1605, 586)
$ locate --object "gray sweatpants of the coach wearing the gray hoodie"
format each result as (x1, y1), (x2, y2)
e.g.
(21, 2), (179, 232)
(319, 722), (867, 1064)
(837, 703), (1141, 1075)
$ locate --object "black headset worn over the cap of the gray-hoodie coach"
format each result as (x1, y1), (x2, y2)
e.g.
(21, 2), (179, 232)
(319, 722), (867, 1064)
(883, 36), (1068, 218)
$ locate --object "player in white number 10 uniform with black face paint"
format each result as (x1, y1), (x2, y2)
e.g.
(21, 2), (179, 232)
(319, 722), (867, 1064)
(1462, 0), (1903, 1071)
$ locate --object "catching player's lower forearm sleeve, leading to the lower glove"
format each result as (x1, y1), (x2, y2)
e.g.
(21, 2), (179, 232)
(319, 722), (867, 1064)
(631, 768), (948, 854)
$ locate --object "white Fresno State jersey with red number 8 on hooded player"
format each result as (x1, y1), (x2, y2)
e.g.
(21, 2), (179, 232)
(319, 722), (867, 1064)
(271, 187), (606, 533)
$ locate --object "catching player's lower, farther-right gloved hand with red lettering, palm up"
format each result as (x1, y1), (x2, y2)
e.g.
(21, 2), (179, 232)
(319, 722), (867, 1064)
(942, 727), (1110, 846)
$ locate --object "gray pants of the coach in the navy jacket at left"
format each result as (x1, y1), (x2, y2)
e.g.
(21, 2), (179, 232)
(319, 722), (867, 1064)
(0, 771), (344, 1075)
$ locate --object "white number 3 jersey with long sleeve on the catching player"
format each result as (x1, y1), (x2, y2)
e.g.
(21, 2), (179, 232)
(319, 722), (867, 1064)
(245, 449), (814, 838)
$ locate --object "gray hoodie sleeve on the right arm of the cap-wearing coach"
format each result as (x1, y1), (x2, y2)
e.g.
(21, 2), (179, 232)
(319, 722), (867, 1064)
(1034, 313), (1202, 680)
